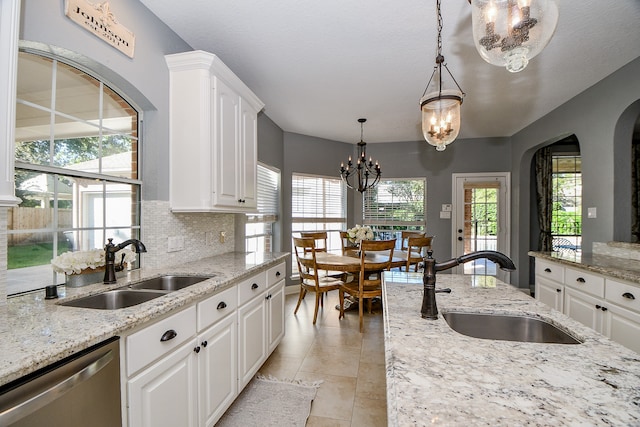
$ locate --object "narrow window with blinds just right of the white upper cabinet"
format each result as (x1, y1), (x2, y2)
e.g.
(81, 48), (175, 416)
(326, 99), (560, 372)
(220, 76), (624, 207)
(245, 164), (280, 252)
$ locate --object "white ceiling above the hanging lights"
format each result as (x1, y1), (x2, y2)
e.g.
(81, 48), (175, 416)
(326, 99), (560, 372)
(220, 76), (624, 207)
(141, 0), (640, 143)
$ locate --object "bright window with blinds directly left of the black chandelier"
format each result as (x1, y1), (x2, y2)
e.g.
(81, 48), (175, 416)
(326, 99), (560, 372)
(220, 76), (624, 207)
(291, 174), (347, 256)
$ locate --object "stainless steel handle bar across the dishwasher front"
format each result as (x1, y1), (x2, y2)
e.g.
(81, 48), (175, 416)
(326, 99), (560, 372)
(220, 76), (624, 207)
(0, 350), (113, 425)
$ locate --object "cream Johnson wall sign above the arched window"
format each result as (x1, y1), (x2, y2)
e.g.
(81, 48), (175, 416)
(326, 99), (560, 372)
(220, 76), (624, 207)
(64, 0), (136, 58)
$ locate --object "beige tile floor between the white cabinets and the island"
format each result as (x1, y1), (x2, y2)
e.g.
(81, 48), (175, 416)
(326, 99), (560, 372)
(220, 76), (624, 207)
(260, 291), (387, 427)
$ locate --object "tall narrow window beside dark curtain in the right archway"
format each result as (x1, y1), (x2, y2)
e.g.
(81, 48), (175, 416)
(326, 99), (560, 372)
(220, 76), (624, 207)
(551, 154), (582, 251)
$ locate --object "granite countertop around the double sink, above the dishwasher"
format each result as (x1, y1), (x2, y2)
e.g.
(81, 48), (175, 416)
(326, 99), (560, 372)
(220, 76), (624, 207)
(0, 253), (289, 385)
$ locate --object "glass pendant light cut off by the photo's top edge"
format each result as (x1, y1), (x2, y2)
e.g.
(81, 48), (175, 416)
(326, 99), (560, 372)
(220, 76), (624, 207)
(469, 0), (558, 73)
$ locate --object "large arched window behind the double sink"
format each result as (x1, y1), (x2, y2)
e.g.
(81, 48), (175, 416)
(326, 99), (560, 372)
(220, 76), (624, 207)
(7, 52), (141, 294)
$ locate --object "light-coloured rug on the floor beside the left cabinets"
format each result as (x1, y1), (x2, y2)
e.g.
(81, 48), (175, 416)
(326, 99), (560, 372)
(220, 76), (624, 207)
(216, 376), (322, 427)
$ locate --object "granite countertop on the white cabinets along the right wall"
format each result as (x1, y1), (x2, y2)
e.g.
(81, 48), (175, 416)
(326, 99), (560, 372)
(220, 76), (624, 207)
(528, 251), (640, 284)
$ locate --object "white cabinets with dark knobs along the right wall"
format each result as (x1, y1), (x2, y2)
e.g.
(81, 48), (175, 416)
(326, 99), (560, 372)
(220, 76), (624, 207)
(535, 258), (640, 353)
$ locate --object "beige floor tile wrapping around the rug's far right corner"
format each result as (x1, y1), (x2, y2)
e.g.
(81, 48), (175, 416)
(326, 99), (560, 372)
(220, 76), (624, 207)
(296, 371), (356, 421)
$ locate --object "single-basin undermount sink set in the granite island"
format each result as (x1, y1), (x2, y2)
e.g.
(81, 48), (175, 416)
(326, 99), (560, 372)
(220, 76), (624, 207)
(443, 312), (581, 344)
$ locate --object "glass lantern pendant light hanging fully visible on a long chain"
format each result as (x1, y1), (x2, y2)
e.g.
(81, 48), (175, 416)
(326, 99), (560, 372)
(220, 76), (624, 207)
(420, 0), (464, 151)
